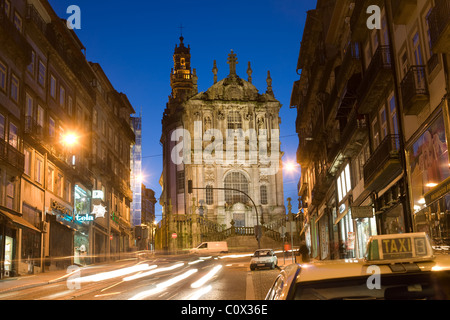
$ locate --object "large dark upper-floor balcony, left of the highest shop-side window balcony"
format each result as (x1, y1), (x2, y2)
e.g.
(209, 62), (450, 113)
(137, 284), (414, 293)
(358, 46), (394, 114)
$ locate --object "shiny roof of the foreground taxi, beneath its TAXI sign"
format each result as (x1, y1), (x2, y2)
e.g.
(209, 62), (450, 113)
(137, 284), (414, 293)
(296, 255), (450, 283)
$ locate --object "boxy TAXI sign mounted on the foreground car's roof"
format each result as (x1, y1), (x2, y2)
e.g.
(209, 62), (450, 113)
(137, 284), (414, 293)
(365, 232), (434, 264)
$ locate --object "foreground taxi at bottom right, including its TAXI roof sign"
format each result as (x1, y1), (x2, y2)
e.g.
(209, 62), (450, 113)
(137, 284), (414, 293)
(266, 233), (450, 300)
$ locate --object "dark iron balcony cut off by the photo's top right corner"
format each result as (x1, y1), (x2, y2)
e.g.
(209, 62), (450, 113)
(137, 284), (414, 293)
(428, 0), (450, 53)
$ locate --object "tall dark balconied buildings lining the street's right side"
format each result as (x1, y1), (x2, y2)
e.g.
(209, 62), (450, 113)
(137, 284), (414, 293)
(291, 0), (449, 259)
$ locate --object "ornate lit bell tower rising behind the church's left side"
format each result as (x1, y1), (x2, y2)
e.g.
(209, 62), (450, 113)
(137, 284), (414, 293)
(170, 36), (194, 100)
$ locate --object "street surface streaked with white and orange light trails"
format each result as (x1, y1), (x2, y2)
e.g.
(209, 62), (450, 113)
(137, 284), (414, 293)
(0, 253), (283, 300)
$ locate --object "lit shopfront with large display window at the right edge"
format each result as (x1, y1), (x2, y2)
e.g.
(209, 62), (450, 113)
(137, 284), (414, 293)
(407, 108), (450, 245)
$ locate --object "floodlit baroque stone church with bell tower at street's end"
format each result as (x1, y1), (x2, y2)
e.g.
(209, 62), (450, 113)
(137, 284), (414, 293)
(160, 37), (285, 246)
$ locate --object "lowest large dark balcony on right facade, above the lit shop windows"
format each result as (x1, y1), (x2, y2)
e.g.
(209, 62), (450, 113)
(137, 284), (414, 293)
(364, 135), (402, 191)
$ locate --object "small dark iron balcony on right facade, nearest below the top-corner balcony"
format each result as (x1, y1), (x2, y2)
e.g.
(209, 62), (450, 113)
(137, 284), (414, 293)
(401, 66), (430, 115)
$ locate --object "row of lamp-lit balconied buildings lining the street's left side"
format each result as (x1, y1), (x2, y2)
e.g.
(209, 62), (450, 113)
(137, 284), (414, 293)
(0, 0), (134, 277)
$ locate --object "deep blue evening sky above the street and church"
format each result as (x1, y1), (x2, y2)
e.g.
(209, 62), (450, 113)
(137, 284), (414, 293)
(49, 0), (316, 220)
